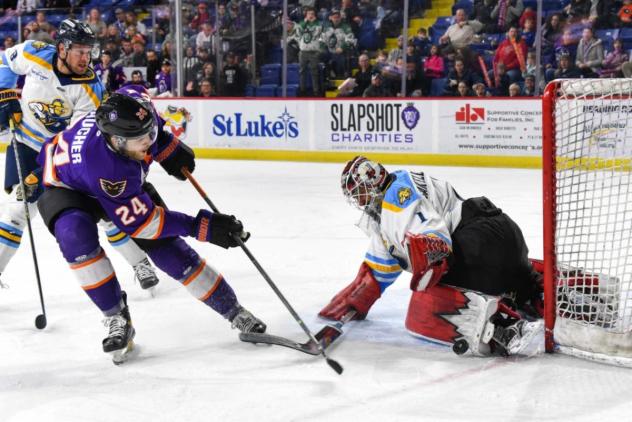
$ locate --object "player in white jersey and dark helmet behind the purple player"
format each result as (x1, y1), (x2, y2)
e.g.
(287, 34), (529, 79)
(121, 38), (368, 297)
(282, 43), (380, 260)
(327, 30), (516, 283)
(0, 19), (158, 290)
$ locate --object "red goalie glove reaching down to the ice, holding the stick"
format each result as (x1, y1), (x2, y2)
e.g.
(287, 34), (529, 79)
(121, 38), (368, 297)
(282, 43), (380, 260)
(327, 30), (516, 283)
(318, 262), (382, 321)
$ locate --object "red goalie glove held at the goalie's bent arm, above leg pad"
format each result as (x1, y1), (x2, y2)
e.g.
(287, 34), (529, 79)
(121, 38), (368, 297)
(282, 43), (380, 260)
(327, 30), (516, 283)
(406, 234), (451, 291)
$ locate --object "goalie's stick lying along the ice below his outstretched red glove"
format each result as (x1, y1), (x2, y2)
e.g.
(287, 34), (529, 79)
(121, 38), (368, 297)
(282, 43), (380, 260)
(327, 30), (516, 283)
(239, 310), (356, 356)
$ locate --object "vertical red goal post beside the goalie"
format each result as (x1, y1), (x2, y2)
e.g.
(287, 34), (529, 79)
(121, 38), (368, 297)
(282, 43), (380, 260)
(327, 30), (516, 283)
(542, 81), (560, 353)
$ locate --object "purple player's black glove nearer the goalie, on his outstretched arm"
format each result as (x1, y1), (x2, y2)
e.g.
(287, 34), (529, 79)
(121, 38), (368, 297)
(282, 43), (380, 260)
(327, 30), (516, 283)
(191, 210), (250, 249)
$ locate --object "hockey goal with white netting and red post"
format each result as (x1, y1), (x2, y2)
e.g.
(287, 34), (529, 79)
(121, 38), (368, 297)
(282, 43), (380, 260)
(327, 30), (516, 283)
(542, 79), (632, 366)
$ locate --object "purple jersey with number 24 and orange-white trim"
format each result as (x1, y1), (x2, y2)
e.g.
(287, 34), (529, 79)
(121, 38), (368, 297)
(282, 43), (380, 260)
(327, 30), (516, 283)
(38, 111), (195, 239)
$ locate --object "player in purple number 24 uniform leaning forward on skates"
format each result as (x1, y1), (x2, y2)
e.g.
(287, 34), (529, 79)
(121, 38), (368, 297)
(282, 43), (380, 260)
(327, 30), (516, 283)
(38, 86), (266, 363)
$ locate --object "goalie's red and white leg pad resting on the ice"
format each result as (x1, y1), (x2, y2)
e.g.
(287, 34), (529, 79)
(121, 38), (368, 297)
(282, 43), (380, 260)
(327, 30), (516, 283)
(406, 285), (499, 356)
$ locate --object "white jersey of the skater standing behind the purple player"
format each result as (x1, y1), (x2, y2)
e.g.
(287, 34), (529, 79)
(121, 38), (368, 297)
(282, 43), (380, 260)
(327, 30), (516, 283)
(0, 41), (104, 151)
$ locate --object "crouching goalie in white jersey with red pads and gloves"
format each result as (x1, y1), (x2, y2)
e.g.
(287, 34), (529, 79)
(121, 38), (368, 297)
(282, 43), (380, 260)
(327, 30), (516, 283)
(319, 157), (544, 356)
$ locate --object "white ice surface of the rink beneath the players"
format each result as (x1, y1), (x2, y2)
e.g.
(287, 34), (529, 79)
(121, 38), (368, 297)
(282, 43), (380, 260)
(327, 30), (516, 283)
(0, 154), (632, 422)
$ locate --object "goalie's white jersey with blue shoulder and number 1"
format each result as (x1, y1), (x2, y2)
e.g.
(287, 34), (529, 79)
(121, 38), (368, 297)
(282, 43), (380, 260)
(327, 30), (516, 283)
(365, 170), (463, 292)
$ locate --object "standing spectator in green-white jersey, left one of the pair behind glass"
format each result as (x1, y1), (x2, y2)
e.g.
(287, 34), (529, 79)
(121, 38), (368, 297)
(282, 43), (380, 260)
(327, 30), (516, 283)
(295, 7), (324, 97)
